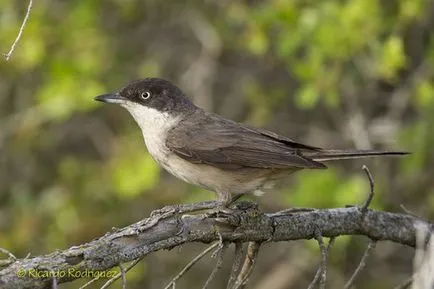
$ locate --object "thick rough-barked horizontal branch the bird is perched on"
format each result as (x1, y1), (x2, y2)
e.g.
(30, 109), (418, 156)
(0, 207), (433, 289)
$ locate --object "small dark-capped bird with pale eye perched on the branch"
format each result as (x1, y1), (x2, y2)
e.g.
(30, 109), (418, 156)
(95, 78), (407, 207)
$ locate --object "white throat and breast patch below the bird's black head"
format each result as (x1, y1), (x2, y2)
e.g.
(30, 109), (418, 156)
(121, 102), (180, 164)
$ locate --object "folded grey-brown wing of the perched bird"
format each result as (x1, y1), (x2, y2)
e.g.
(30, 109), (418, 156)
(166, 112), (325, 170)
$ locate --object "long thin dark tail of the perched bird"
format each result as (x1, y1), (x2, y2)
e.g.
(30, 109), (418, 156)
(309, 149), (410, 162)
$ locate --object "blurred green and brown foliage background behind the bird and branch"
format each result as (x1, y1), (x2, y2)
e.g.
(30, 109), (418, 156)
(0, 0), (434, 289)
